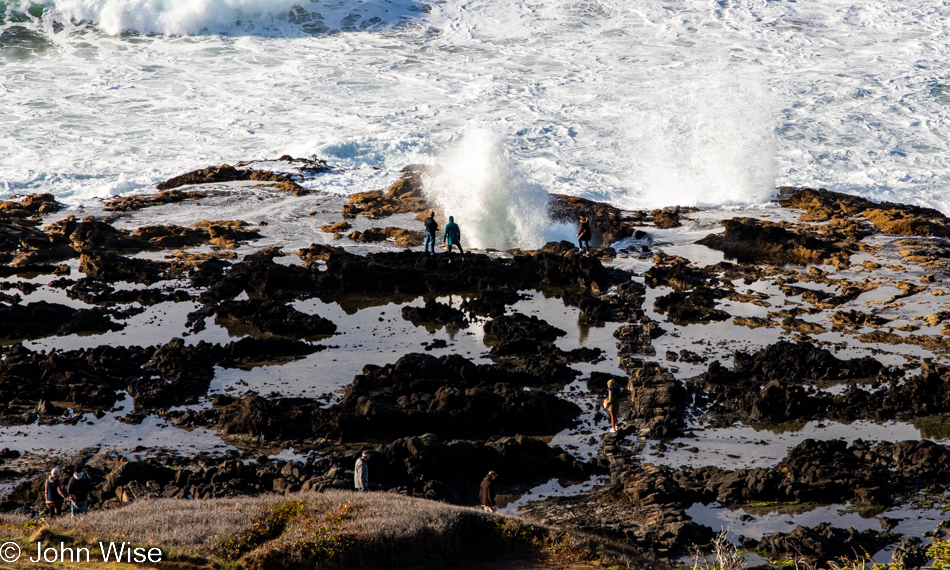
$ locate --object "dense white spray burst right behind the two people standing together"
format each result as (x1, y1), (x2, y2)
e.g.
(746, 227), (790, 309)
(424, 128), (573, 250)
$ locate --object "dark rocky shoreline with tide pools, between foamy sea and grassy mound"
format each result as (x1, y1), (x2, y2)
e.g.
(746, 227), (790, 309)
(0, 157), (950, 566)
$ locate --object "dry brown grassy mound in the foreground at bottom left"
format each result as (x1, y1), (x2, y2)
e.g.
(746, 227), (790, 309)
(0, 491), (648, 569)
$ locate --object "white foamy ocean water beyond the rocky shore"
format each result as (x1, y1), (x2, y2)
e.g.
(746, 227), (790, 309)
(0, 0), (950, 217)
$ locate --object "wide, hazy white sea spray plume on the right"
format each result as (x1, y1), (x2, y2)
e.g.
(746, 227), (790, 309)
(612, 64), (775, 208)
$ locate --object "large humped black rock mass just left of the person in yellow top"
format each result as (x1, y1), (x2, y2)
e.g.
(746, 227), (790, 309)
(216, 354), (580, 441)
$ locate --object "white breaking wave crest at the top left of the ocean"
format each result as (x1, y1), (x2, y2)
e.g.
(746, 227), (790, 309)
(47, 0), (301, 35)
